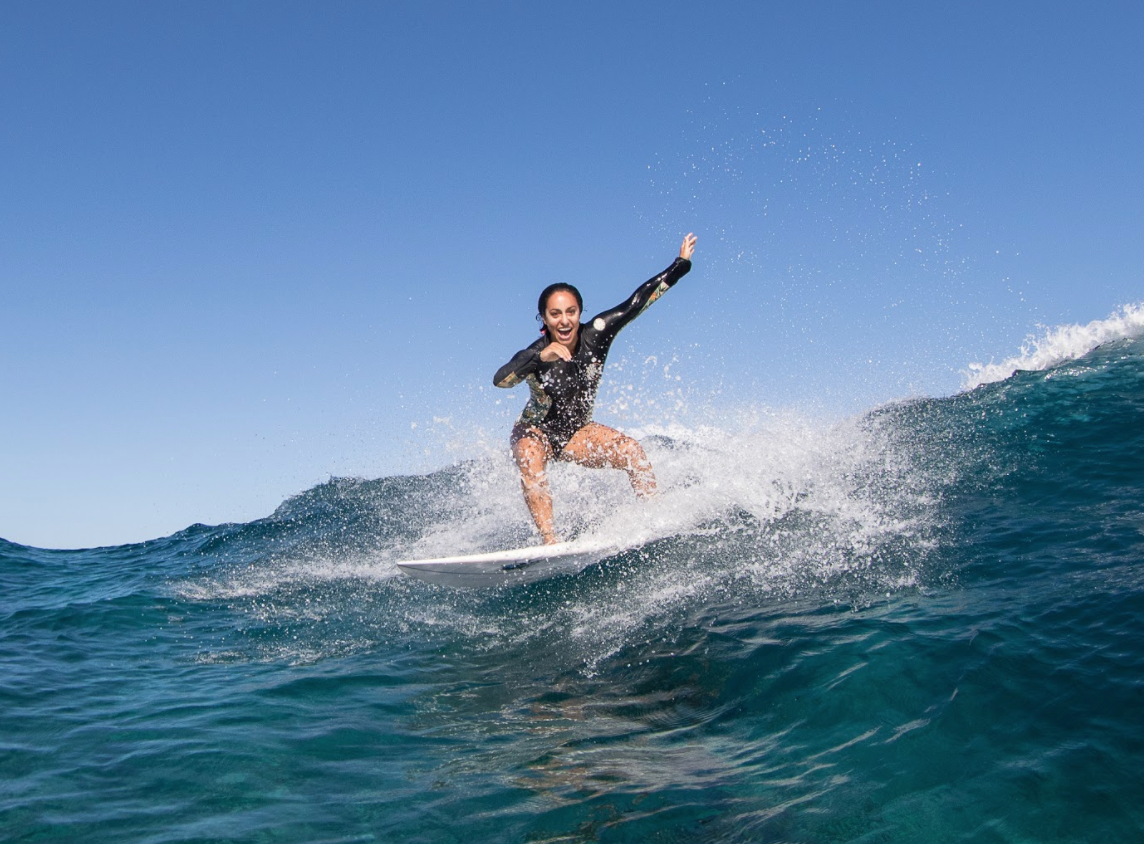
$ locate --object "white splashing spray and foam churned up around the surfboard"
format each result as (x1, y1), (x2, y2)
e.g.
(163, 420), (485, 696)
(176, 395), (942, 672)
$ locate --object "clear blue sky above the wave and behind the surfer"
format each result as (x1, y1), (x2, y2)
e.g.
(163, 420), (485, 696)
(0, 0), (1144, 547)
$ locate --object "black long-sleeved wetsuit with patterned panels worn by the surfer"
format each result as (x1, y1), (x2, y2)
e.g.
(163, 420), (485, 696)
(493, 258), (691, 454)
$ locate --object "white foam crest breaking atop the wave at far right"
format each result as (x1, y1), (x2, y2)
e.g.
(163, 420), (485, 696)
(961, 303), (1144, 390)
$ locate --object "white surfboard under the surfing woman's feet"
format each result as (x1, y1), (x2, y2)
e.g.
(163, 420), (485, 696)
(397, 541), (622, 588)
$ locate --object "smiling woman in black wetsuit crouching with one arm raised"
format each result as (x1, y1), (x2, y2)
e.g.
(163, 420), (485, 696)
(493, 234), (697, 544)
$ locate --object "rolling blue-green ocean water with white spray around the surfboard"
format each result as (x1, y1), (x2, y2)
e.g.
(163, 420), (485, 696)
(0, 332), (1144, 844)
